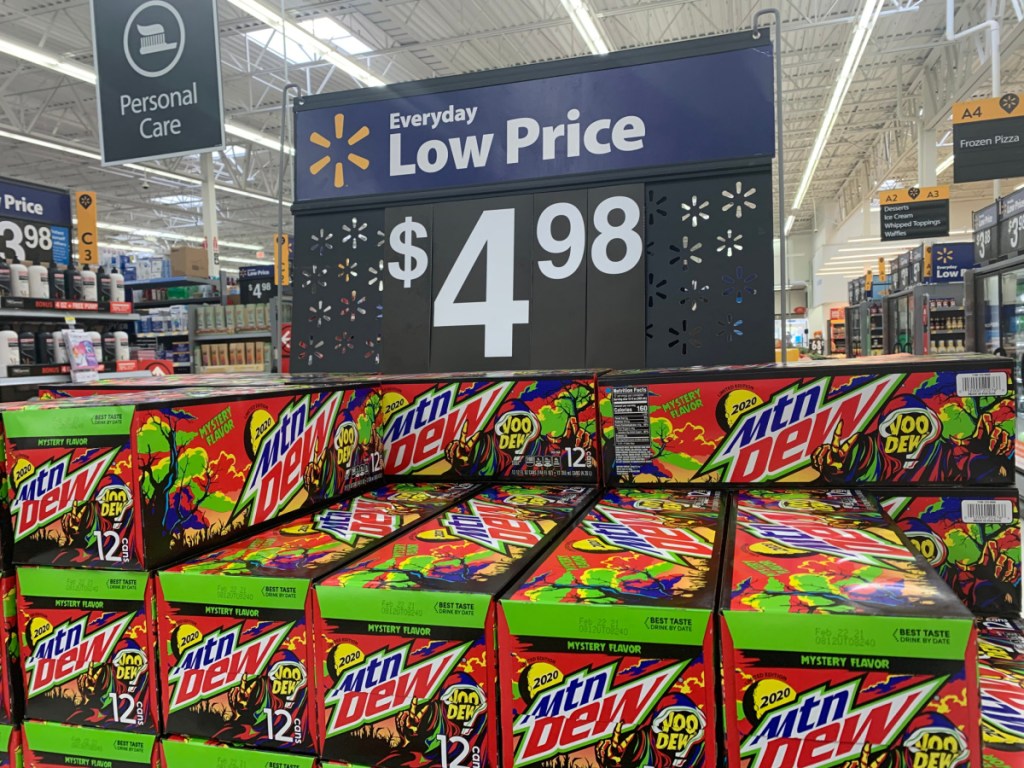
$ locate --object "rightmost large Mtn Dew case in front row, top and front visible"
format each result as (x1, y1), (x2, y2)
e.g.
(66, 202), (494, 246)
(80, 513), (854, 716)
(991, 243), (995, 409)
(720, 490), (982, 768)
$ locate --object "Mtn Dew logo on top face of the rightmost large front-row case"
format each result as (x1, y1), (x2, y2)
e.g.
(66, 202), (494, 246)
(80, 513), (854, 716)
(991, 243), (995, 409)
(738, 509), (914, 566)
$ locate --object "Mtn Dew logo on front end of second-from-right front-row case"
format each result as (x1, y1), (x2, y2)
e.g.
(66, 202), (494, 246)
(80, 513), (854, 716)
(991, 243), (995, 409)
(512, 662), (686, 765)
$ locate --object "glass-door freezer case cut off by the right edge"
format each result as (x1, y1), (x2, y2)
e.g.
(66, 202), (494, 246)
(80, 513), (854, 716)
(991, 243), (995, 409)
(967, 256), (1024, 473)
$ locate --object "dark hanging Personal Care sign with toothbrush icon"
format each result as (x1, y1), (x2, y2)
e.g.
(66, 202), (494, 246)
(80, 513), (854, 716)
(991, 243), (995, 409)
(92, 0), (224, 164)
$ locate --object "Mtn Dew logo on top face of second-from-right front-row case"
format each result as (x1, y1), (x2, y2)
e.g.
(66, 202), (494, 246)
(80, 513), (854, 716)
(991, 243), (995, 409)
(583, 504), (715, 565)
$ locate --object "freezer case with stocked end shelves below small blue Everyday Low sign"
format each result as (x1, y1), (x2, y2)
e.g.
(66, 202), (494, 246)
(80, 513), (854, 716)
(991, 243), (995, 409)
(885, 283), (967, 354)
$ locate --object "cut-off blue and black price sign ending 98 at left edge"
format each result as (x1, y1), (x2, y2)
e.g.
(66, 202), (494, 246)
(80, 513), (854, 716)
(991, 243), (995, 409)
(0, 178), (71, 264)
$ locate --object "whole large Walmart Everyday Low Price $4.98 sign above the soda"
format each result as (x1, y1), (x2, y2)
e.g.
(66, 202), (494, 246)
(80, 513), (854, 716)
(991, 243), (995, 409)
(292, 33), (774, 372)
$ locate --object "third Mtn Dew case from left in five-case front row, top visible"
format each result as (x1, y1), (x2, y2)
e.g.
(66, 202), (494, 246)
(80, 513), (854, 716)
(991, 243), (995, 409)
(315, 486), (593, 768)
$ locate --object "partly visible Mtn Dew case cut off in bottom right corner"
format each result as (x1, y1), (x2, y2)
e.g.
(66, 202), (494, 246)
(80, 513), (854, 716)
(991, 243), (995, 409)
(978, 616), (1024, 768)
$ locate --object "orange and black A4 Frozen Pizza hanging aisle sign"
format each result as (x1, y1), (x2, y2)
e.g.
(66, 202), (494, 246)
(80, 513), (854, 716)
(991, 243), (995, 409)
(953, 93), (1024, 183)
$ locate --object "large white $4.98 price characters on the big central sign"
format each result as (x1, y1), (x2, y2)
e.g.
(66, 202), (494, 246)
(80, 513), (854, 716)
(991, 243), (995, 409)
(387, 196), (643, 357)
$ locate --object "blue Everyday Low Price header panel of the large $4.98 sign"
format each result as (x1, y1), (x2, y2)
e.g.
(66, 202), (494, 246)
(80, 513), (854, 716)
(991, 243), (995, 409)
(295, 45), (775, 202)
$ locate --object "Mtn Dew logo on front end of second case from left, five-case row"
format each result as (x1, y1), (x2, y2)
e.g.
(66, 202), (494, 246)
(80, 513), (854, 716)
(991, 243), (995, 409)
(168, 622), (295, 713)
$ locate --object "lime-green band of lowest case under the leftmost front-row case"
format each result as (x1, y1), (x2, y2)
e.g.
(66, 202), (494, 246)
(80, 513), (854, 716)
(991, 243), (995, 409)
(22, 720), (160, 768)
